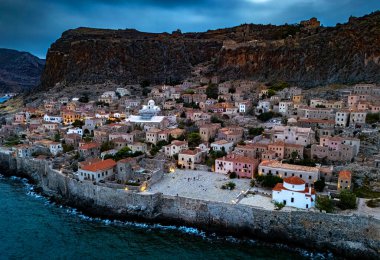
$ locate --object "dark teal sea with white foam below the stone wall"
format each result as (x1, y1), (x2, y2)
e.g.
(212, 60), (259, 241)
(0, 175), (334, 260)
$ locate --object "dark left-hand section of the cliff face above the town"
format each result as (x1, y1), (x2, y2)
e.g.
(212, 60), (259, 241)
(42, 28), (222, 87)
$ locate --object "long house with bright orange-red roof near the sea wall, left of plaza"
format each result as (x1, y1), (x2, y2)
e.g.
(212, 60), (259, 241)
(77, 159), (116, 182)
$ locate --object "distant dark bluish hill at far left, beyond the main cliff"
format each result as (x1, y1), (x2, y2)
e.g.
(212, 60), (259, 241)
(0, 48), (45, 93)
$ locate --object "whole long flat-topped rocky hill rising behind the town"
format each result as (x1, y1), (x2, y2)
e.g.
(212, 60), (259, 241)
(42, 12), (380, 89)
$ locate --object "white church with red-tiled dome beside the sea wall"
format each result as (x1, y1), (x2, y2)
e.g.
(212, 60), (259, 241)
(272, 176), (315, 209)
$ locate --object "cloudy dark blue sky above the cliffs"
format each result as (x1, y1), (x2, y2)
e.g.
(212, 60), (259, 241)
(0, 0), (380, 58)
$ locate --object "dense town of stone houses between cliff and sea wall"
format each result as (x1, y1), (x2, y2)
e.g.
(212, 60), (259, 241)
(0, 80), (380, 218)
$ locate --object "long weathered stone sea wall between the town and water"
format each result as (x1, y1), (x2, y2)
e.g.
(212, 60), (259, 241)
(0, 152), (380, 259)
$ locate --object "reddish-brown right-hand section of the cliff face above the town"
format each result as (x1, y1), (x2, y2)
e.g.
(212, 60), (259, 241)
(216, 14), (380, 87)
